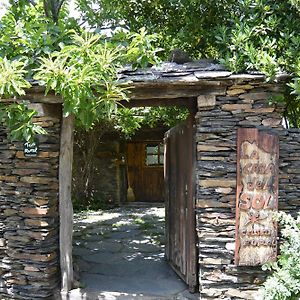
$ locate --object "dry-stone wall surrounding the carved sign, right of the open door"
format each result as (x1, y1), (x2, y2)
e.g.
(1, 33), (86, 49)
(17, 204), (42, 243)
(196, 78), (300, 299)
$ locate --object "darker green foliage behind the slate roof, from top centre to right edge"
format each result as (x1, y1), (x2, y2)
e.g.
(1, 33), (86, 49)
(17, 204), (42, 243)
(77, 0), (300, 127)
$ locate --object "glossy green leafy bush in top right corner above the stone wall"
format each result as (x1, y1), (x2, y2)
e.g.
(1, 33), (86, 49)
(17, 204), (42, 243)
(216, 0), (300, 78)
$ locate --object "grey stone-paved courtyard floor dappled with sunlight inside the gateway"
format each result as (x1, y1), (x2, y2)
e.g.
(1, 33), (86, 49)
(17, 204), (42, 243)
(70, 206), (199, 300)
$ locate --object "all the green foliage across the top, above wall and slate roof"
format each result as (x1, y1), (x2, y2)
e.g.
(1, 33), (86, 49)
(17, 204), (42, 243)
(0, 0), (300, 139)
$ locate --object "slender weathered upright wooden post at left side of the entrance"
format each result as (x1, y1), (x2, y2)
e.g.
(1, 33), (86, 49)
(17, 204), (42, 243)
(59, 115), (74, 296)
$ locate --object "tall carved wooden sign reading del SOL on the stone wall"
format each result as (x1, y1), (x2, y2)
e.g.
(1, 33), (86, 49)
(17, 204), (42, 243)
(235, 128), (279, 266)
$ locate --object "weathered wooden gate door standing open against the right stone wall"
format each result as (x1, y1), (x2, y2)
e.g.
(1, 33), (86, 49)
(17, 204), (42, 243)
(164, 115), (197, 292)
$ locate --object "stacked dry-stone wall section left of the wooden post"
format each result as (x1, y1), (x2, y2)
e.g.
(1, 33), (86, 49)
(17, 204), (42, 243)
(0, 104), (61, 299)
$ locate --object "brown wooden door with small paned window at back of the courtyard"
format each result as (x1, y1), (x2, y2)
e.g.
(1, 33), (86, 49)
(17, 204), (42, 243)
(127, 141), (164, 202)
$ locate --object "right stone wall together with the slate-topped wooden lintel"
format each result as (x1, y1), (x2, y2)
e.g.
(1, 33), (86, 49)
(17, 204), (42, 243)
(120, 60), (300, 300)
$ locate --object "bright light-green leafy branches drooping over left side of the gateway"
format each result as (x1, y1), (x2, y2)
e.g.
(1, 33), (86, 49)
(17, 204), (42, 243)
(0, 0), (164, 134)
